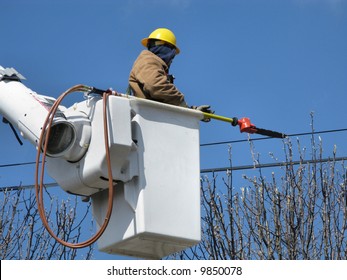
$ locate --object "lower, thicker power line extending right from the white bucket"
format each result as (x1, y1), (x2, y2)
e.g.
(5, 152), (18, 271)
(200, 157), (347, 173)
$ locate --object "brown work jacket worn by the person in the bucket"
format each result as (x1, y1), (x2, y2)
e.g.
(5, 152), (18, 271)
(129, 50), (187, 107)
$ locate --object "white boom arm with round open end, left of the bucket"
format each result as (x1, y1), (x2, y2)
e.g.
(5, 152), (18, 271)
(0, 66), (90, 161)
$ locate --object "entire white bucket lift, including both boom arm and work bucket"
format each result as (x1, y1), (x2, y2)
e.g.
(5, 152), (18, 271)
(0, 68), (202, 258)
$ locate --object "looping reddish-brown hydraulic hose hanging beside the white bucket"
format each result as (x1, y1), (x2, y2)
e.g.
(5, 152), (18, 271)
(35, 85), (114, 249)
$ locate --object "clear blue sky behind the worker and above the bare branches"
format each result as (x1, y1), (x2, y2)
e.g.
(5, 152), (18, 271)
(0, 0), (347, 260)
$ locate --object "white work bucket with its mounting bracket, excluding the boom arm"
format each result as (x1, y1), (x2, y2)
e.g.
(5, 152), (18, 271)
(47, 92), (201, 258)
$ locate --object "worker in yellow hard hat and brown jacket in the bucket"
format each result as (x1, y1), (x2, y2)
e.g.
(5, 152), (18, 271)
(129, 28), (213, 116)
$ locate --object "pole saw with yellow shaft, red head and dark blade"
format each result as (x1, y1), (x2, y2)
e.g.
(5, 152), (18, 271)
(202, 112), (287, 138)
